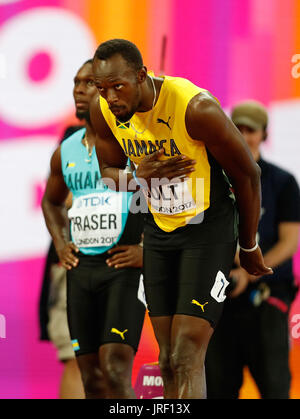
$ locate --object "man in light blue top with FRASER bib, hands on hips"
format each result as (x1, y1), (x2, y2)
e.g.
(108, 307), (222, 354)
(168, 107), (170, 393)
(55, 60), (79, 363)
(42, 61), (145, 399)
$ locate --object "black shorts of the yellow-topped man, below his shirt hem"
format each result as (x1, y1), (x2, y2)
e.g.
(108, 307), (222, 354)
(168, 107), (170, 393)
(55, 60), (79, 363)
(144, 242), (236, 327)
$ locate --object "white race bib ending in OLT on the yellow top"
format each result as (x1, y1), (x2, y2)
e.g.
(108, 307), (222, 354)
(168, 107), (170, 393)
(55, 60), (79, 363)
(145, 181), (196, 215)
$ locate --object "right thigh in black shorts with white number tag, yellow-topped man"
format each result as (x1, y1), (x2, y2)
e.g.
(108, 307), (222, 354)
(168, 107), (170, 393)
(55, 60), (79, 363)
(176, 242), (236, 327)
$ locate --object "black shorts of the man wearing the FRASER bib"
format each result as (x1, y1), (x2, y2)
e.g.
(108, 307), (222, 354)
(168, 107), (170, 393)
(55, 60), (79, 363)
(67, 253), (145, 356)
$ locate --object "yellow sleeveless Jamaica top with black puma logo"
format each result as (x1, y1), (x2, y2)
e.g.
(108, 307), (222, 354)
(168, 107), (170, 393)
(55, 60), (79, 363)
(99, 76), (230, 232)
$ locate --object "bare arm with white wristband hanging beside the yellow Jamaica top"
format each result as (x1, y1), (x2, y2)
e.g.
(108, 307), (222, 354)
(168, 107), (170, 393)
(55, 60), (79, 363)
(185, 93), (272, 275)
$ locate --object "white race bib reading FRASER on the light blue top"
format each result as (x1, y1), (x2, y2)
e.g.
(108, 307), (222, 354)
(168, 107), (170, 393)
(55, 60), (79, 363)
(68, 192), (122, 248)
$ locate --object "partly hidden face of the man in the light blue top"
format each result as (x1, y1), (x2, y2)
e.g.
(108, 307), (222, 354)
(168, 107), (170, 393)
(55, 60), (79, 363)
(73, 63), (97, 121)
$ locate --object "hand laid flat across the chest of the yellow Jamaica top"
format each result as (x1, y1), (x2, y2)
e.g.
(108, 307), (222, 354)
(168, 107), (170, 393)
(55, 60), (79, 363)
(136, 148), (196, 186)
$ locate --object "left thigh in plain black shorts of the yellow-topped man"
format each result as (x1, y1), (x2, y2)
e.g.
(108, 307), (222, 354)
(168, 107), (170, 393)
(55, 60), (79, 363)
(144, 249), (181, 318)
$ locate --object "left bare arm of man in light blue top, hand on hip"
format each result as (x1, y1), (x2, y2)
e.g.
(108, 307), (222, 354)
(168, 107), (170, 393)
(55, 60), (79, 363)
(42, 147), (78, 269)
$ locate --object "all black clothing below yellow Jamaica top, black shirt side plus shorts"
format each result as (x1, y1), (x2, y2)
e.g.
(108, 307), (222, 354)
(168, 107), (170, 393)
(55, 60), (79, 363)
(144, 198), (238, 327)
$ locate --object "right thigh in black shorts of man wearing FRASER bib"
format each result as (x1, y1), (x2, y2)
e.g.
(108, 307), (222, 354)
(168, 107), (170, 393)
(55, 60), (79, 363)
(97, 268), (146, 351)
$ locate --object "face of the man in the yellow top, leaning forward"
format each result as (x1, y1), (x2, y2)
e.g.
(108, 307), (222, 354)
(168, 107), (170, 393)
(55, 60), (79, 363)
(93, 54), (143, 122)
